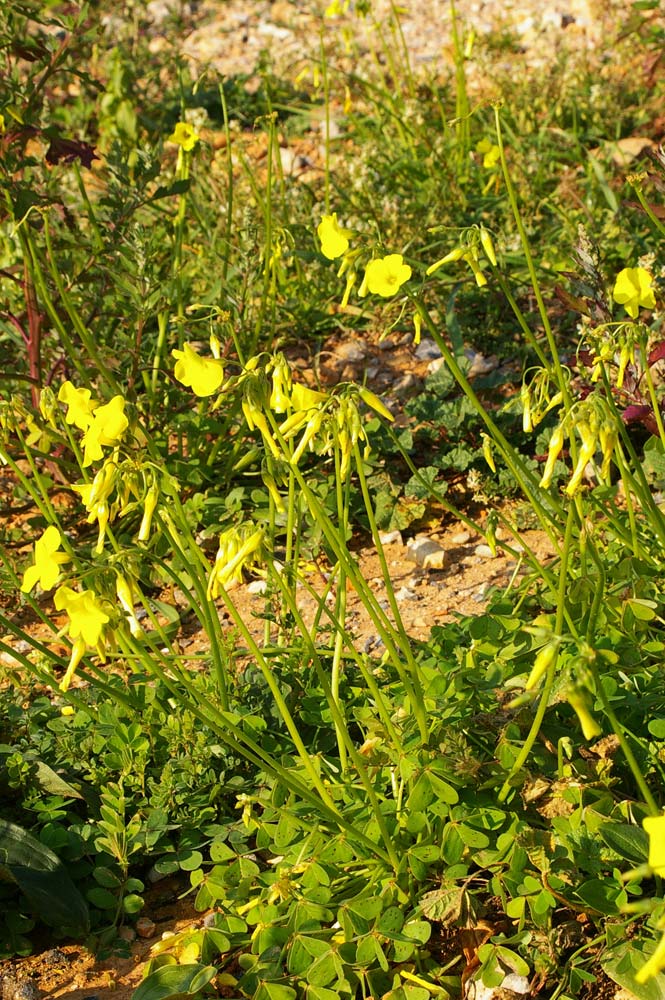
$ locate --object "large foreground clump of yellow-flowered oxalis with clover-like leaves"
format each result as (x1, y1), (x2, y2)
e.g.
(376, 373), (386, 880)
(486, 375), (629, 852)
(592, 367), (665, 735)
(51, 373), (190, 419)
(0, 3), (665, 1000)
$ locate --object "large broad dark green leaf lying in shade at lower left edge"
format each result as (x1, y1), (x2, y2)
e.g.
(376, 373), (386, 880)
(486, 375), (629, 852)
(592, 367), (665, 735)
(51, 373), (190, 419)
(0, 820), (89, 931)
